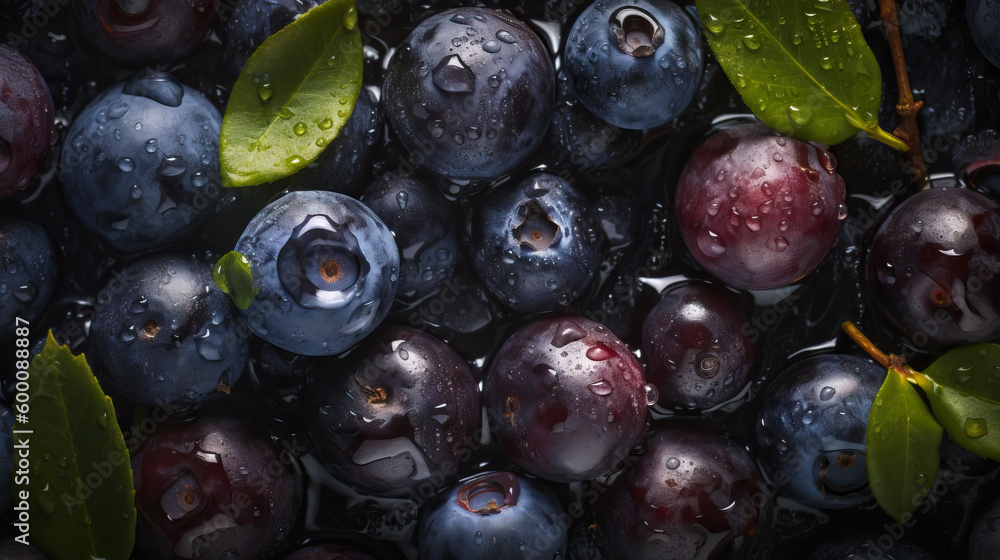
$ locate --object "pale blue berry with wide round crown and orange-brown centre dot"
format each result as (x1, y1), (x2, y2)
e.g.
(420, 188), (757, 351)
(236, 191), (399, 356)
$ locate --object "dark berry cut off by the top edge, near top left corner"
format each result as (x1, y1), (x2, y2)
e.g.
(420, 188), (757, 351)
(73, 0), (217, 67)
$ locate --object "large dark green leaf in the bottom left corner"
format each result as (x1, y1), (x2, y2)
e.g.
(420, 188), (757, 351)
(14, 332), (136, 560)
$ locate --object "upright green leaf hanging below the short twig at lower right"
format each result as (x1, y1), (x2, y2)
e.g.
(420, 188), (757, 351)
(865, 369), (943, 523)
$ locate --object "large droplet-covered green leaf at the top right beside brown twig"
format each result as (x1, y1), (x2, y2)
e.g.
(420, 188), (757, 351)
(697, 0), (908, 150)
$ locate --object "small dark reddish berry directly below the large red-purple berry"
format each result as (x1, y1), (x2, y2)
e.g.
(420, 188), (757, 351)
(642, 283), (757, 410)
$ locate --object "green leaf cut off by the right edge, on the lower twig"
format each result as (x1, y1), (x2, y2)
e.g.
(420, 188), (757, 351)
(917, 344), (1000, 461)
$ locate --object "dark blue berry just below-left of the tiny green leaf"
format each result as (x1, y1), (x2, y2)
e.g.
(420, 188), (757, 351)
(89, 255), (249, 408)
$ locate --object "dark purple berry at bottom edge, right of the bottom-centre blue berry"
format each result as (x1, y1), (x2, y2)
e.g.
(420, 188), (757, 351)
(595, 425), (761, 560)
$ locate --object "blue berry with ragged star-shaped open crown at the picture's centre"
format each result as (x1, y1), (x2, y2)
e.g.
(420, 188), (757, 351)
(468, 173), (604, 313)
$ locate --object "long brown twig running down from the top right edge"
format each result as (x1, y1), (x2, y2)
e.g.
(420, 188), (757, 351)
(878, 0), (931, 191)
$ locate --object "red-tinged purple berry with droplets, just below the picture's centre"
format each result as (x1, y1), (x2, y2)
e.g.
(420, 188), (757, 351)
(483, 317), (655, 482)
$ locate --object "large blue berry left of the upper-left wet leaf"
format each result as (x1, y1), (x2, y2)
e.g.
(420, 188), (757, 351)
(60, 69), (222, 254)
